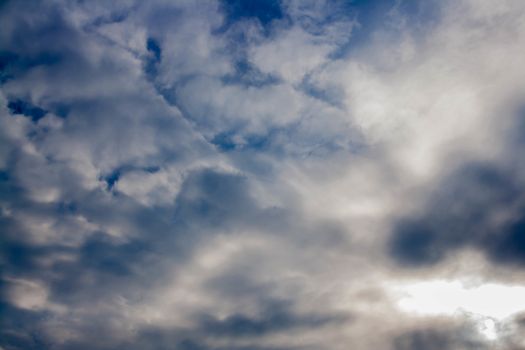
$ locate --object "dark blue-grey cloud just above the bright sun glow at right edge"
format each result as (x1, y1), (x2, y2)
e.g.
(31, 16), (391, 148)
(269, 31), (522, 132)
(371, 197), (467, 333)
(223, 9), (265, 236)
(389, 150), (525, 267)
